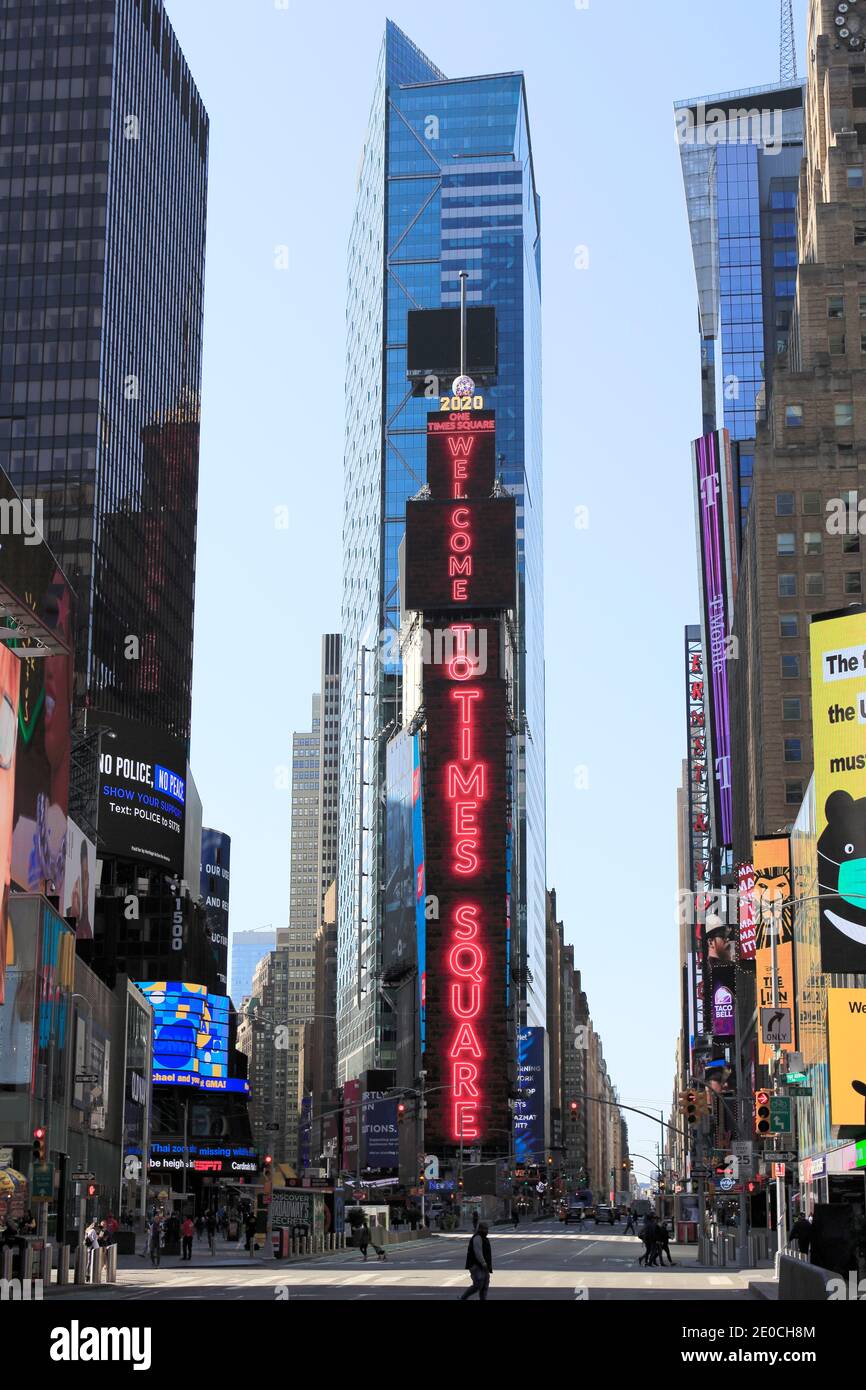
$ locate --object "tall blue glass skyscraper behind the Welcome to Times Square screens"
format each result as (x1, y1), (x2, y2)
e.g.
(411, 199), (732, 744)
(338, 24), (546, 1081)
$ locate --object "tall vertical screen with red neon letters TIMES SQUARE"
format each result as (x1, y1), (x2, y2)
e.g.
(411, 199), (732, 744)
(424, 656), (510, 1144)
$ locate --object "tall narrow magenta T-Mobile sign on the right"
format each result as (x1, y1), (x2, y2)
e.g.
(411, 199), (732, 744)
(694, 431), (737, 845)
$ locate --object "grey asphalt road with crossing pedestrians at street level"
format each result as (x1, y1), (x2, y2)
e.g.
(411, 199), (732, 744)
(60, 1222), (766, 1302)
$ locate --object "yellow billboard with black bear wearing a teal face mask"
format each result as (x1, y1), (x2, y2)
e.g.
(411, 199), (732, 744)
(809, 607), (866, 974)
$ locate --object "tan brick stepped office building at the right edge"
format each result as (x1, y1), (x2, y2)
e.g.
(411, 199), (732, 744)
(734, 0), (866, 859)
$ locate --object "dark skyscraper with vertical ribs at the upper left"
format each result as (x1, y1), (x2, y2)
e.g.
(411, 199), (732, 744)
(0, 0), (209, 739)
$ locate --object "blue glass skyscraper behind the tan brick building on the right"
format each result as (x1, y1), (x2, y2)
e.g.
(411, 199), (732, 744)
(674, 83), (803, 531)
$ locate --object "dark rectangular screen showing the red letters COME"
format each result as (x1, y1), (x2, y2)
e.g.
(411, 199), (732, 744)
(405, 496), (517, 613)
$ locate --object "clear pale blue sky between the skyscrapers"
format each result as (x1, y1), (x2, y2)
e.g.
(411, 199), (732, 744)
(165, 0), (805, 1179)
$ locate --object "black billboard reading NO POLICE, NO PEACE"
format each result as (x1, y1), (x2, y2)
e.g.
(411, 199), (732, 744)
(93, 710), (186, 874)
